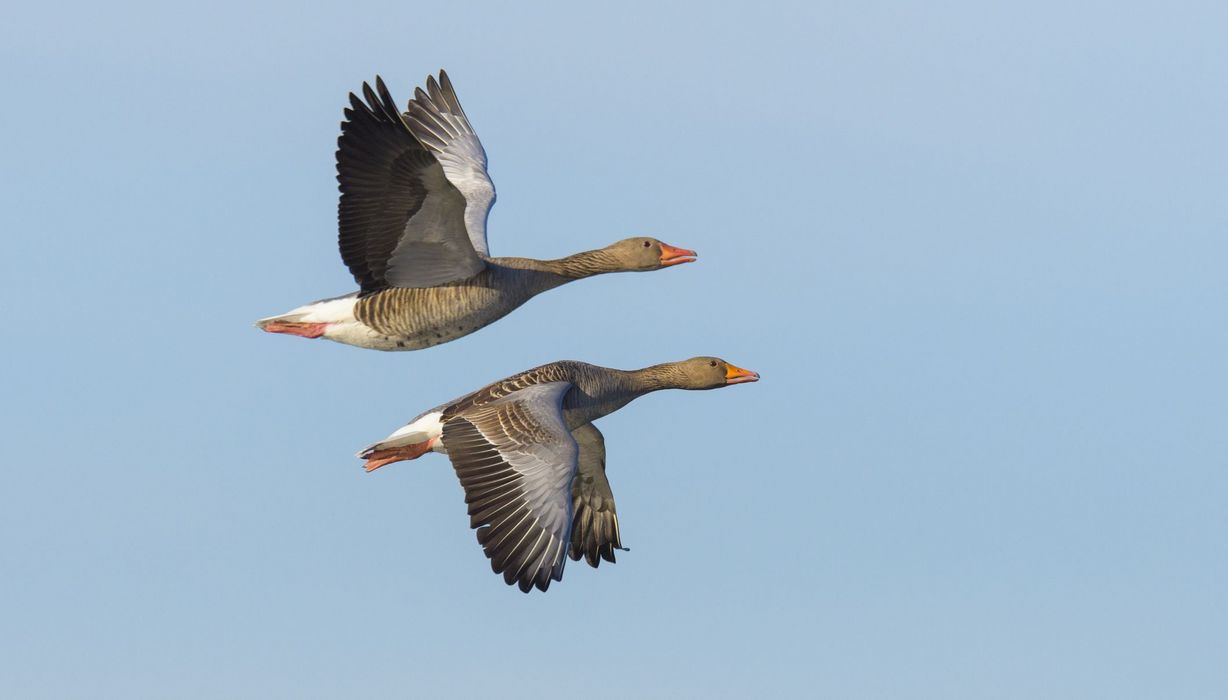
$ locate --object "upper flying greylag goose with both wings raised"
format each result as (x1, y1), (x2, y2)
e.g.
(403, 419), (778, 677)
(257, 70), (696, 350)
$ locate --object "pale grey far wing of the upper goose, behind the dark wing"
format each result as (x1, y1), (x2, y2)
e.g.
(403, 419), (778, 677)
(405, 70), (495, 257)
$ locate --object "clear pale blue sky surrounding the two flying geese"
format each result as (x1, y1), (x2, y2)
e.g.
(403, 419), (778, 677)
(0, 2), (1228, 699)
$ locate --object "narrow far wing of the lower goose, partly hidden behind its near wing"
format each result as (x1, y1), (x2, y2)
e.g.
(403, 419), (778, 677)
(569, 424), (623, 569)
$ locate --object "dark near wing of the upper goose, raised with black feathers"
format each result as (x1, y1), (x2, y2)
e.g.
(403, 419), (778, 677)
(336, 77), (489, 295)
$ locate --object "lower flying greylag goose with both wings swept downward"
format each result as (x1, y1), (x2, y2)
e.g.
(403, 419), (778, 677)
(359, 357), (759, 593)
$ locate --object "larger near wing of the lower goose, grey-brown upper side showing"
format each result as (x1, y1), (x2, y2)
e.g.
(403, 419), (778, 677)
(443, 382), (578, 593)
